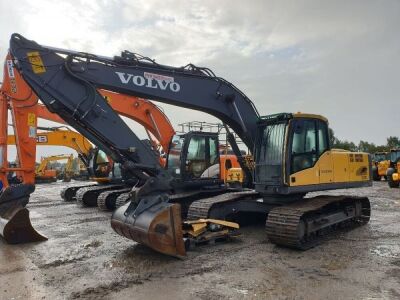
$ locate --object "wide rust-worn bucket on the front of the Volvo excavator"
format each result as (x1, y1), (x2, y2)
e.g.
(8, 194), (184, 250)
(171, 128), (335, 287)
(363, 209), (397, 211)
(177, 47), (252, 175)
(111, 202), (186, 257)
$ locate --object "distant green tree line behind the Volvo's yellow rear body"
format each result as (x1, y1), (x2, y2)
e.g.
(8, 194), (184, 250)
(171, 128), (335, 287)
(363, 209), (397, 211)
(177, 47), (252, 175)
(329, 128), (400, 153)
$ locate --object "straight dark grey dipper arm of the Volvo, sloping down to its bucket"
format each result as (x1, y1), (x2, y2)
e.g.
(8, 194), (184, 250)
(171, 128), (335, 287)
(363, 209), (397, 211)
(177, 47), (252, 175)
(11, 37), (162, 180)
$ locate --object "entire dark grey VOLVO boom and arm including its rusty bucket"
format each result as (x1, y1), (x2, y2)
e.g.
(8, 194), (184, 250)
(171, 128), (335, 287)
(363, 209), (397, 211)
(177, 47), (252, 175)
(10, 34), (259, 256)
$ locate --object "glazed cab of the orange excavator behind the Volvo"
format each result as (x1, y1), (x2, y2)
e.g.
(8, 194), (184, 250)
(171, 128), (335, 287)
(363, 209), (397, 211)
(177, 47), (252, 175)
(167, 131), (220, 185)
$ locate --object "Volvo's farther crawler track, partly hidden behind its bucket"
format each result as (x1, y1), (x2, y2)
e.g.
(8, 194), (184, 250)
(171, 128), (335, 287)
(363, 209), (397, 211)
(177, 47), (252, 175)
(187, 190), (259, 220)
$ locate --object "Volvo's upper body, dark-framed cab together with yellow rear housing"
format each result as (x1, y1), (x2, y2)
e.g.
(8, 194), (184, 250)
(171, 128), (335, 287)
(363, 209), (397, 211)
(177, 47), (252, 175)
(255, 113), (371, 198)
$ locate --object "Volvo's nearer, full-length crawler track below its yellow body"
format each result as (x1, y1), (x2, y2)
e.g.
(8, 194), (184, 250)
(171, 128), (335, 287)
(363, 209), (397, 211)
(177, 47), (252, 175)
(266, 196), (371, 250)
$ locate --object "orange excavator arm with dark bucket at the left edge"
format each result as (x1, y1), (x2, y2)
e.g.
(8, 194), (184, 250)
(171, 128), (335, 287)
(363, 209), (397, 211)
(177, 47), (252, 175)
(0, 53), (47, 243)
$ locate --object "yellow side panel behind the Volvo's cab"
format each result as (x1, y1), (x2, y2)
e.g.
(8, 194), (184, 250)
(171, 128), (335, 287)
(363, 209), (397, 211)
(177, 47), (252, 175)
(289, 149), (370, 186)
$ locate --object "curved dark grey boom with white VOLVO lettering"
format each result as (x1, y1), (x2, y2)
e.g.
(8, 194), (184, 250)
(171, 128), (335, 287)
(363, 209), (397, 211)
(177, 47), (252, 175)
(11, 34), (259, 170)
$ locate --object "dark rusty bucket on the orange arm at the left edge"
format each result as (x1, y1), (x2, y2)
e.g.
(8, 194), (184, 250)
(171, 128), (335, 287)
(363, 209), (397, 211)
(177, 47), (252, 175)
(0, 184), (47, 244)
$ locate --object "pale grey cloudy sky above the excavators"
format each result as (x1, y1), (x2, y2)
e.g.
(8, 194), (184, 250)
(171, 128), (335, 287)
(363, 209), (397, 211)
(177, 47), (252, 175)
(0, 0), (400, 159)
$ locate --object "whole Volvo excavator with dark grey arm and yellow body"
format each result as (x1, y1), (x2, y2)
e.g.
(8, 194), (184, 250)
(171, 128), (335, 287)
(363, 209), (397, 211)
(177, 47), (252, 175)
(3, 34), (371, 256)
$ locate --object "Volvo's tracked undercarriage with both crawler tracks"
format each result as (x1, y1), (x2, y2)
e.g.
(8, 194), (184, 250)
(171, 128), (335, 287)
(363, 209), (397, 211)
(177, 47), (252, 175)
(187, 191), (371, 250)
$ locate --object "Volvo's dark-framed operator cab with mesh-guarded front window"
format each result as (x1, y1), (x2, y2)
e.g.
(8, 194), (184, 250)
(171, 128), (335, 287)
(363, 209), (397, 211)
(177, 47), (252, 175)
(256, 114), (329, 193)
